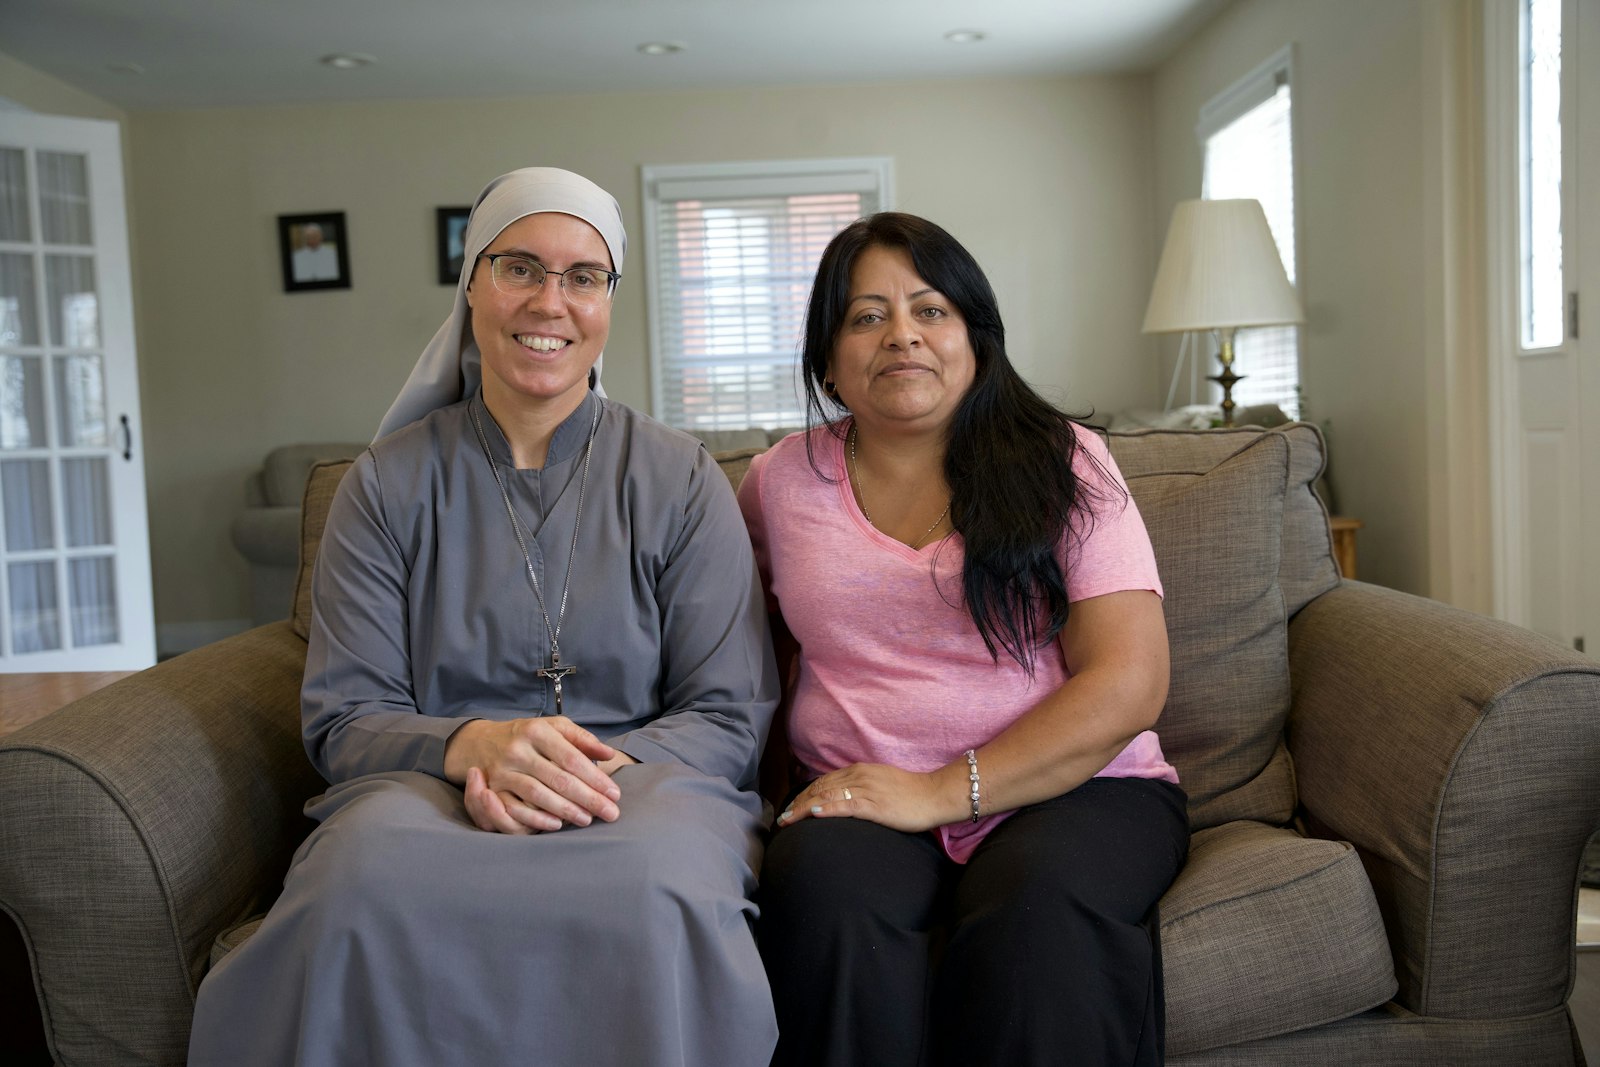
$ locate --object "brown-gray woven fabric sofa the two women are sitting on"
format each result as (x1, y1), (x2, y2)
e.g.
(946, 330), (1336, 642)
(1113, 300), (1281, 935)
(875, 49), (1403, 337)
(0, 424), (1600, 1067)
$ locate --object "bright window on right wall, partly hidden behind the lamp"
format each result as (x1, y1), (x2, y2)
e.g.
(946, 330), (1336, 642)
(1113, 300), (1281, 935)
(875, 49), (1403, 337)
(1198, 50), (1304, 418)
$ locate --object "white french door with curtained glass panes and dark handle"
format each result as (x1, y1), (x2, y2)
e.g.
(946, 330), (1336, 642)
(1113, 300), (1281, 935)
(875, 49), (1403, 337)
(0, 112), (155, 672)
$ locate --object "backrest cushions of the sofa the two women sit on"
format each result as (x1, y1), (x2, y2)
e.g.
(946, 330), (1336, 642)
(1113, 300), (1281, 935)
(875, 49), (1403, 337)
(293, 424), (1339, 829)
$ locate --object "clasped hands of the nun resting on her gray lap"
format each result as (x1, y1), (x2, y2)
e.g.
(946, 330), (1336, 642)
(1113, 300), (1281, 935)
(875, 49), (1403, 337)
(445, 715), (638, 833)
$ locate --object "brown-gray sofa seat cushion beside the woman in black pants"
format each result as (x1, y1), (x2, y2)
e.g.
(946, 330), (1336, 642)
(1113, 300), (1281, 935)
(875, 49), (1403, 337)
(1162, 822), (1395, 1056)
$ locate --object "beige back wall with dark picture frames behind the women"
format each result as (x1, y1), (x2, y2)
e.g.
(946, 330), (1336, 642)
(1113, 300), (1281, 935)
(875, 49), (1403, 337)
(130, 77), (1157, 643)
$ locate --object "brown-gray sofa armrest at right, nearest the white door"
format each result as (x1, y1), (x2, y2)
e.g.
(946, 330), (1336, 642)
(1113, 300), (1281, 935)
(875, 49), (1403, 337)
(1288, 582), (1600, 1019)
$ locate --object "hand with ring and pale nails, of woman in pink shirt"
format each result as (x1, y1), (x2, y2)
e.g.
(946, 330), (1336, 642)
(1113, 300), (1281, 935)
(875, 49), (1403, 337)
(778, 761), (971, 833)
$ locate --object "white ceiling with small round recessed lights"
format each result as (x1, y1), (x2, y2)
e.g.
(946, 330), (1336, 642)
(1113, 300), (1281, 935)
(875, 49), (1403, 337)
(0, 0), (1232, 110)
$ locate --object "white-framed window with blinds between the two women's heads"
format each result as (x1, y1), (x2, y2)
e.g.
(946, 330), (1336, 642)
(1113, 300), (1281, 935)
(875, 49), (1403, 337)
(643, 158), (890, 430)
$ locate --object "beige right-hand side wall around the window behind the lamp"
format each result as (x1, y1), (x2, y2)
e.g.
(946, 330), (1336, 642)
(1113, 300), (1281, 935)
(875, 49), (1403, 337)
(1152, 0), (1445, 595)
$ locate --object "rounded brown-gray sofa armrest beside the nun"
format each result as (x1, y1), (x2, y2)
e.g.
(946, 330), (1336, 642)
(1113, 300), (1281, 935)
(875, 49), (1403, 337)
(0, 622), (325, 1064)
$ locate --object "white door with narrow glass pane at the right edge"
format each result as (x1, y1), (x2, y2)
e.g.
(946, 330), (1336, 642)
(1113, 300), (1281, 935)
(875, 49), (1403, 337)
(1485, 0), (1600, 654)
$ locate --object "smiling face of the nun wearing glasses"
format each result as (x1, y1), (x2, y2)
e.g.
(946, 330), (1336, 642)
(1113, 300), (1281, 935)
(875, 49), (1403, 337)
(467, 211), (611, 418)
